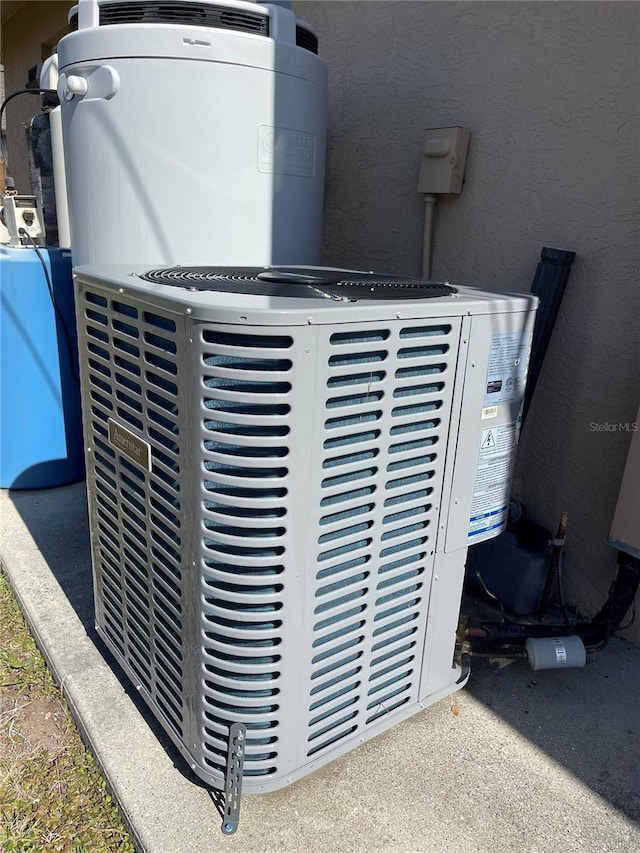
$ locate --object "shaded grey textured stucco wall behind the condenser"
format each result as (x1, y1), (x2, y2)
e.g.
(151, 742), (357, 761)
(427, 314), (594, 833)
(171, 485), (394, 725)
(293, 0), (640, 640)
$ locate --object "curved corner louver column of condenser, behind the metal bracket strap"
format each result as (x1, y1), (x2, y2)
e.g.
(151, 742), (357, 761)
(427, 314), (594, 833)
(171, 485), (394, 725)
(202, 329), (293, 777)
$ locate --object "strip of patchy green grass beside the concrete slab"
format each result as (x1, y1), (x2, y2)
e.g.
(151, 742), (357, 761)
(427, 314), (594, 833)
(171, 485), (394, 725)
(0, 572), (135, 853)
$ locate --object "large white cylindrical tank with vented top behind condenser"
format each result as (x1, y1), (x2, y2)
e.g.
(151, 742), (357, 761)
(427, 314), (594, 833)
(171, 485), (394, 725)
(58, 0), (326, 266)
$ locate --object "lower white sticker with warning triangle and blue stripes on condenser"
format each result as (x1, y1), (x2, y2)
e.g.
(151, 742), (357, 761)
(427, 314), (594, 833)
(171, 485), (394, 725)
(468, 422), (518, 545)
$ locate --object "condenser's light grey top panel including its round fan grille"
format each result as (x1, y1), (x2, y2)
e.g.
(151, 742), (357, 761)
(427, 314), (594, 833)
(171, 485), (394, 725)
(74, 264), (535, 326)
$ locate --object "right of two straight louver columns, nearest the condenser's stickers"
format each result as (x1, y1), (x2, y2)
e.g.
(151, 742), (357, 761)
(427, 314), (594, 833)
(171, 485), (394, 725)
(366, 325), (455, 723)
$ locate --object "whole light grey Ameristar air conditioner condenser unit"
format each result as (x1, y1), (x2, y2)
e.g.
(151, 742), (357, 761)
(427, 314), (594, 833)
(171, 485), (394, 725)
(76, 267), (536, 824)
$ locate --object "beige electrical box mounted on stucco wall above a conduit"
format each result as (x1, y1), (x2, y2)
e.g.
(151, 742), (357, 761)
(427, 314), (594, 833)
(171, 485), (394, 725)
(418, 127), (469, 195)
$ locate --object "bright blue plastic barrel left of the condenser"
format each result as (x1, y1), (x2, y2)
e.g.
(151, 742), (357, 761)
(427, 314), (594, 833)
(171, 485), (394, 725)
(0, 246), (84, 489)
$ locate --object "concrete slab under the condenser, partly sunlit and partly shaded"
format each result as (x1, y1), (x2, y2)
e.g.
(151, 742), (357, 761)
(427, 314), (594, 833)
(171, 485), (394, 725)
(0, 484), (640, 853)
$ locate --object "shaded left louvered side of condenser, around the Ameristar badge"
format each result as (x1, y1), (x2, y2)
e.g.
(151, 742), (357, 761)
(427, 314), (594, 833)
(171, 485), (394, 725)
(80, 291), (184, 735)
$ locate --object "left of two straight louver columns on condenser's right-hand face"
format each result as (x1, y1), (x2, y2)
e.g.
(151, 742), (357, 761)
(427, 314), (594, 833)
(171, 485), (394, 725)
(307, 328), (390, 756)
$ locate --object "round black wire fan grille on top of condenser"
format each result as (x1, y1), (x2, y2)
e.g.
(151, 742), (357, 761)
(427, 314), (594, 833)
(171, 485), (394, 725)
(140, 267), (456, 302)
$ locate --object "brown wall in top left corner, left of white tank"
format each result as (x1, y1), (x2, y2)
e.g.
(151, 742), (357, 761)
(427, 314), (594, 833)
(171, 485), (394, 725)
(2, 0), (74, 193)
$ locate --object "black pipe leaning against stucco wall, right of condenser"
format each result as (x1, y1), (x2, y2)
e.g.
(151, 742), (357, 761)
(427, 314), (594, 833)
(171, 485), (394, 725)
(520, 246), (576, 429)
